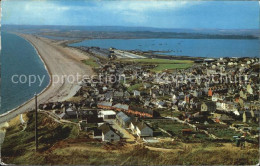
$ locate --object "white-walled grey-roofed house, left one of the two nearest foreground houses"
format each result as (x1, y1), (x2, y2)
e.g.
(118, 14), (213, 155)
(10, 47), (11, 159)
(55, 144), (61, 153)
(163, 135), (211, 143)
(99, 123), (120, 142)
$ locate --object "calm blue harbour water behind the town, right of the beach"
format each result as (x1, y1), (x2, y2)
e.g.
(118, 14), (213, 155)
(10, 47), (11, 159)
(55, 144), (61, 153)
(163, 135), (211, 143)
(70, 39), (260, 58)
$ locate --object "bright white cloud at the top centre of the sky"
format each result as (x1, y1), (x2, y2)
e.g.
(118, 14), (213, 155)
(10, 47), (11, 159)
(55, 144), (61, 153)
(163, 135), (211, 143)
(97, 1), (202, 25)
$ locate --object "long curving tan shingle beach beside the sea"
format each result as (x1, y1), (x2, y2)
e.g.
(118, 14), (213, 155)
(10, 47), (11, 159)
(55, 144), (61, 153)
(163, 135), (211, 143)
(0, 34), (94, 124)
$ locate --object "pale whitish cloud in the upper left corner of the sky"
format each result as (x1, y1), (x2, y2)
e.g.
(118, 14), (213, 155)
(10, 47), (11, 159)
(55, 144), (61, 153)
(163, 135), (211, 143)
(2, 0), (80, 25)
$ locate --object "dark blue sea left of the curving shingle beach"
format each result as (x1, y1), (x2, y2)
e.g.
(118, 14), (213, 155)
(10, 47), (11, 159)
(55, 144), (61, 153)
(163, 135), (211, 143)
(0, 32), (50, 114)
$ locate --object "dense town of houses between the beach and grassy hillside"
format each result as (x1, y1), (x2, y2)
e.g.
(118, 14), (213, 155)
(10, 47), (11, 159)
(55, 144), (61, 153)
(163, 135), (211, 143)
(39, 48), (260, 148)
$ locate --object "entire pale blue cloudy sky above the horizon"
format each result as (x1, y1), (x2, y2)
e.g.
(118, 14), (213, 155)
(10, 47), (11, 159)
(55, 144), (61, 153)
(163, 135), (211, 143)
(2, 0), (260, 29)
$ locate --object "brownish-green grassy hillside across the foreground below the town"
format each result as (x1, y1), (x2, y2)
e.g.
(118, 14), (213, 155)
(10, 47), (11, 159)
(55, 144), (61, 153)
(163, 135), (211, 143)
(2, 113), (259, 165)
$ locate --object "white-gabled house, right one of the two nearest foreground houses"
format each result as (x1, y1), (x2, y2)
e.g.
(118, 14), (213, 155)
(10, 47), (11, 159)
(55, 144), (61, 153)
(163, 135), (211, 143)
(130, 120), (153, 137)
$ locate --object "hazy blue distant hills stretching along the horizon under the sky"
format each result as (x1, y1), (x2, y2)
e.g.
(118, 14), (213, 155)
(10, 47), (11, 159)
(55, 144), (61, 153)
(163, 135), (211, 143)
(2, 25), (260, 39)
